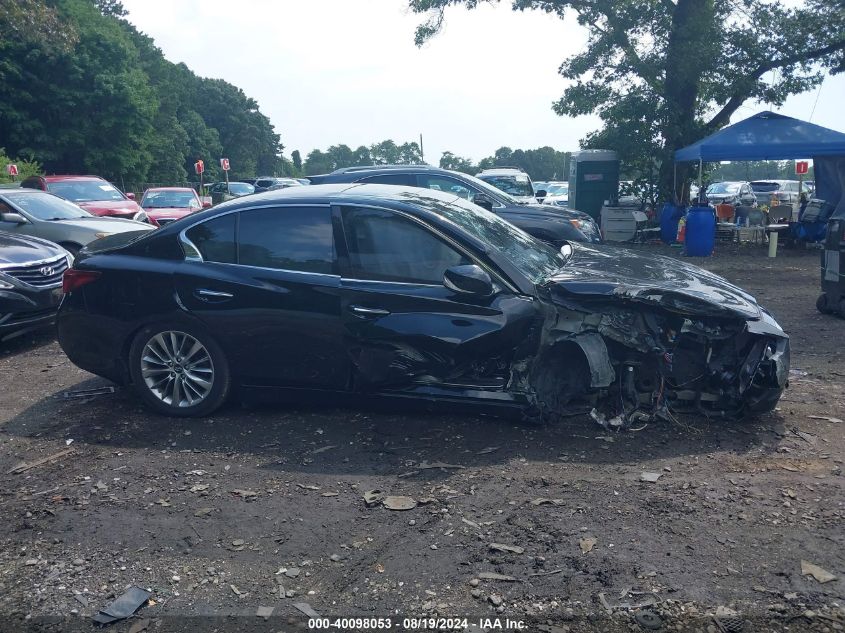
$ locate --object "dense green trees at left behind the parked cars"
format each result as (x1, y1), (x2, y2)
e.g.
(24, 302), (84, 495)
(0, 0), (284, 184)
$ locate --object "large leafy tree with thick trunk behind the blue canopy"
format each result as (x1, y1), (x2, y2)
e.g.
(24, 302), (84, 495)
(409, 0), (845, 196)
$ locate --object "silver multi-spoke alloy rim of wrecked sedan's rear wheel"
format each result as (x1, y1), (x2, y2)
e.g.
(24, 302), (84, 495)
(141, 331), (214, 407)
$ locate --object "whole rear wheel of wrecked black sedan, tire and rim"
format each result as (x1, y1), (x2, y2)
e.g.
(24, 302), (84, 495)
(129, 324), (231, 417)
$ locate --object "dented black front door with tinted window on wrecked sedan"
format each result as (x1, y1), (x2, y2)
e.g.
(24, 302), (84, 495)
(334, 207), (537, 391)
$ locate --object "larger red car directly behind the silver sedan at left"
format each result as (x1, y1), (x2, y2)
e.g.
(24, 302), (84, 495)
(21, 176), (147, 222)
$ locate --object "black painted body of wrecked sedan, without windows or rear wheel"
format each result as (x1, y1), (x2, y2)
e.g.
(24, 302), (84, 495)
(58, 185), (788, 414)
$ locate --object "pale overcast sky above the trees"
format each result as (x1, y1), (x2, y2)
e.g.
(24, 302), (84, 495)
(123, 0), (845, 164)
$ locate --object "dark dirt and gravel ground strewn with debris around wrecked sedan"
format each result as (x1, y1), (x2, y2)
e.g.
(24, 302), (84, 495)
(0, 246), (845, 633)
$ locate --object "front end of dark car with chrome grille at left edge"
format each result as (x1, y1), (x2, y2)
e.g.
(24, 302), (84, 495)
(0, 232), (68, 340)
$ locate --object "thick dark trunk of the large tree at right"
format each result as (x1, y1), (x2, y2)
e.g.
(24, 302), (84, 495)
(659, 0), (718, 202)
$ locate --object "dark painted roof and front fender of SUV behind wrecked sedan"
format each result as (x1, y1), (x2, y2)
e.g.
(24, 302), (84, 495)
(308, 165), (601, 247)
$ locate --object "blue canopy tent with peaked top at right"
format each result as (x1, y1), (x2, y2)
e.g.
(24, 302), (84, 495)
(675, 112), (845, 214)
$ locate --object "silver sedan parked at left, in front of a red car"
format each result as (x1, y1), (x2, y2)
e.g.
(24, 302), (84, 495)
(0, 189), (154, 256)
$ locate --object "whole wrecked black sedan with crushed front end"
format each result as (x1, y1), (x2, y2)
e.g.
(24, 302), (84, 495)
(58, 184), (789, 426)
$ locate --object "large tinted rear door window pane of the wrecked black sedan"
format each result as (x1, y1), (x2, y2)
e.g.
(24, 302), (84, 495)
(238, 206), (335, 274)
